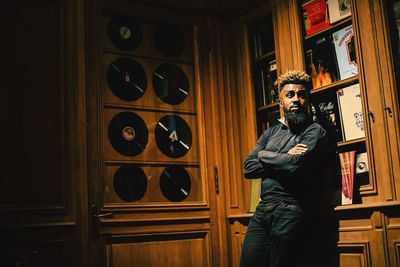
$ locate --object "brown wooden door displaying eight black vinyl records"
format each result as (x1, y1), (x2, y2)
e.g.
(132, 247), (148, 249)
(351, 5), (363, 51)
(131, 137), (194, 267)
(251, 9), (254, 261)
(87, 1), (222, 267)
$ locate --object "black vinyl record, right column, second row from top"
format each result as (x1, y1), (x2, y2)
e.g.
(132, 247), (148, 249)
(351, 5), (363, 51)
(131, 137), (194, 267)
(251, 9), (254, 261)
(153, 64), (189, 105)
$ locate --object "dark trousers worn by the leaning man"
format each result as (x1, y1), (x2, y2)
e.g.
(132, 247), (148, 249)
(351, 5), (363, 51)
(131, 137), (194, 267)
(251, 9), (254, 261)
(240, 202), (306, 267)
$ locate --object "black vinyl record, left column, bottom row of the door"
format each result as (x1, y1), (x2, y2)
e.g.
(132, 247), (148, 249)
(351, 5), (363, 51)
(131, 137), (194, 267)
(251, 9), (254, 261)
(114, 164), (147, 202)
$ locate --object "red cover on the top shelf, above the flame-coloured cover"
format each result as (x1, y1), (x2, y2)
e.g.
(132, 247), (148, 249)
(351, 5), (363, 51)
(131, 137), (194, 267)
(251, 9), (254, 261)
(301, 0), (329, 36)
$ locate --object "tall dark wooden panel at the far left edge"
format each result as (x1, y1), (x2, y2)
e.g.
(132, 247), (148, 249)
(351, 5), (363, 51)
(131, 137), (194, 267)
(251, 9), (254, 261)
(0, 1), (66, 214)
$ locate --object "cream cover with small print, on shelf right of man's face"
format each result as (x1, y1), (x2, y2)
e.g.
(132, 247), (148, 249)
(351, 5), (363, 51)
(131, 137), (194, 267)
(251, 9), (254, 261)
(337, 84), (365, 141)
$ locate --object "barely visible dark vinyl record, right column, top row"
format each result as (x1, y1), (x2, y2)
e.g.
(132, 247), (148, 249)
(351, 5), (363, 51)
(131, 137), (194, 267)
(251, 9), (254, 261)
(154, 23), (185, 57)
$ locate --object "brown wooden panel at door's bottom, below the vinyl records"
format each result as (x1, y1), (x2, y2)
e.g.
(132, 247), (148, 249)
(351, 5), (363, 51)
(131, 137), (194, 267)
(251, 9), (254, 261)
(107, 232), (211, 267)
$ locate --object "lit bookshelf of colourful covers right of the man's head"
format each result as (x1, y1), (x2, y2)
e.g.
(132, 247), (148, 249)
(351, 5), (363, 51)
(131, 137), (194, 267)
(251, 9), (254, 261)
(299, 0), (370, 205)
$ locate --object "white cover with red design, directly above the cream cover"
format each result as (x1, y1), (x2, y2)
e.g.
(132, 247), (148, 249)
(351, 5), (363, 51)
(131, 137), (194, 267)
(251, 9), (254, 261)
(332, 25), (358, 80)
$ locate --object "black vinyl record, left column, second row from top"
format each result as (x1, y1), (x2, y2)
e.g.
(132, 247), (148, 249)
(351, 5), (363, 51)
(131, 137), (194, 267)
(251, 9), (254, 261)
(107, 57), (147, 101)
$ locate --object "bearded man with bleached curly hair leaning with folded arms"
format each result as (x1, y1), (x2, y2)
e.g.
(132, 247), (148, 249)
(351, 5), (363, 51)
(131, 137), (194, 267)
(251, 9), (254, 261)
(240, 71), (327, 267)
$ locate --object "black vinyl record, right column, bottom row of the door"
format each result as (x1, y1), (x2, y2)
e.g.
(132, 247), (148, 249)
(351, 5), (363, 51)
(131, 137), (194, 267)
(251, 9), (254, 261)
(160, 165), (192, 202)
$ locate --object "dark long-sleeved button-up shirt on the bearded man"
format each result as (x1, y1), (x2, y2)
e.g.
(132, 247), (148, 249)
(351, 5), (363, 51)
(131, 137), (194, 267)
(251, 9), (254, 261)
(244, 122), (327, 208)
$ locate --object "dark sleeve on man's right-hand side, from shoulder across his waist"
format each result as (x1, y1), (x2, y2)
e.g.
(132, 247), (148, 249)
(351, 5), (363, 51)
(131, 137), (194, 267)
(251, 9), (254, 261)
(254, 124), (327, 174)
